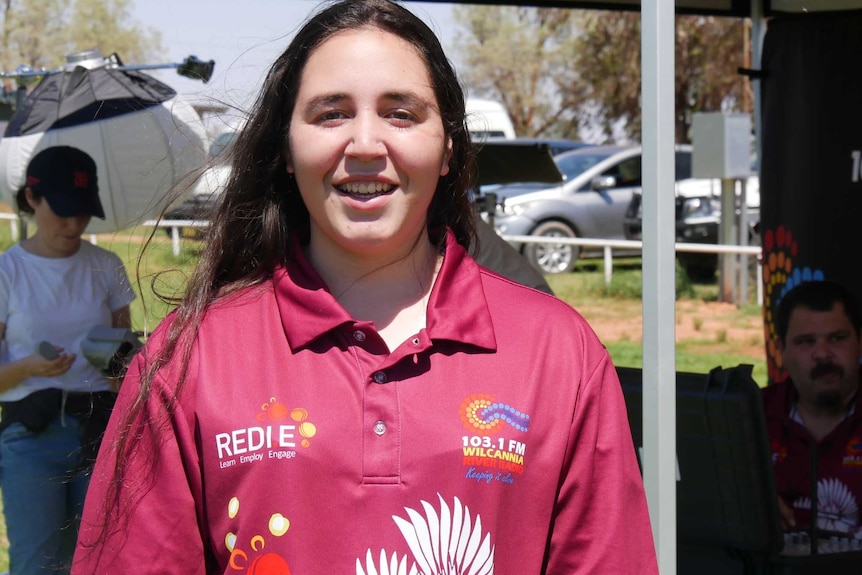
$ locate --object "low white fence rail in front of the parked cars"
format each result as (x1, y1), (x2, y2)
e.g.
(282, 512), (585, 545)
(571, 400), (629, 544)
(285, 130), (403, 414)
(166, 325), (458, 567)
(0, 212), (763, 305)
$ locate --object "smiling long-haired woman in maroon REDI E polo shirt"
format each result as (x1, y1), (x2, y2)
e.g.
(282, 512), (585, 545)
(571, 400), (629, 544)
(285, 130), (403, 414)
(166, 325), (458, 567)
(73, 0), (656, 575)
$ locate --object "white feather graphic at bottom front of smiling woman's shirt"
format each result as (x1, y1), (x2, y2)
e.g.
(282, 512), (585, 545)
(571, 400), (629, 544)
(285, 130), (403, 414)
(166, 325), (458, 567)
(356, 493), (494, 575)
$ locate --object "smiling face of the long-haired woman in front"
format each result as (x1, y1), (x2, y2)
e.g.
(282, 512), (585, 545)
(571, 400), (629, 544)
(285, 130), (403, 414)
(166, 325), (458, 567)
(287, 28), (451, 259)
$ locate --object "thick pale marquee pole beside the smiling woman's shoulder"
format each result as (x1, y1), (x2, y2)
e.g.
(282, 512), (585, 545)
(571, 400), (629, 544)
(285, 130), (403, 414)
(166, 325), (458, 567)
(641, 0), (676, 575)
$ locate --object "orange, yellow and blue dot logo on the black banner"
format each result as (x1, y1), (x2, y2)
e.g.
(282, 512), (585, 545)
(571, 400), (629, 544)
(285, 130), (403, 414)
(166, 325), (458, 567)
(763, 226), (824, 381)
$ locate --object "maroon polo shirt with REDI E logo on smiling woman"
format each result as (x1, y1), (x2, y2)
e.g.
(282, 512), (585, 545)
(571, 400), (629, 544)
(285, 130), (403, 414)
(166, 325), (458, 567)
(73, 234), (657, 575)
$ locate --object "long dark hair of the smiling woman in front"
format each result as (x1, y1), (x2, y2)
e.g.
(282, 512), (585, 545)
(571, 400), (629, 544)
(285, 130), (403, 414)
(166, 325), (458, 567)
(100, 0), (475, 539)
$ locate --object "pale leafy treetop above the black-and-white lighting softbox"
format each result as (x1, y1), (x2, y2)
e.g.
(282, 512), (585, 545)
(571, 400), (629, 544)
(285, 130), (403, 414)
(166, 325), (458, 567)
(0, 0), (164, 89)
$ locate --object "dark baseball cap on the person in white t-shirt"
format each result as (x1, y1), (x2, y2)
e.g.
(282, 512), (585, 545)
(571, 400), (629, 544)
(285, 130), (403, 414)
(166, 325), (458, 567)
(26, 146), (105, 220)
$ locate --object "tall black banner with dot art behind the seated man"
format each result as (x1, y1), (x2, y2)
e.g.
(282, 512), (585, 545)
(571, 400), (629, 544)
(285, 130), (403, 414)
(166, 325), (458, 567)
(760, 11), (862, 382)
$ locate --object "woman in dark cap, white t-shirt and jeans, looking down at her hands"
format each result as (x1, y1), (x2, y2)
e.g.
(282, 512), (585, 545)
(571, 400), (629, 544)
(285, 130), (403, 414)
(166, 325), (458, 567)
(0, 146), (134, 575)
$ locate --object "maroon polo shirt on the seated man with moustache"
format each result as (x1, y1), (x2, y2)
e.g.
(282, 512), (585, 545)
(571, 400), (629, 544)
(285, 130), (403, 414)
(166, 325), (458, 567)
(763, 380), (862, 538)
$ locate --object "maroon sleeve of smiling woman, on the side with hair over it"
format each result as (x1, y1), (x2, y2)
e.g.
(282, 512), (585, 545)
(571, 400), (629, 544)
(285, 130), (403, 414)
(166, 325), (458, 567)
(72, 340), (212, 575)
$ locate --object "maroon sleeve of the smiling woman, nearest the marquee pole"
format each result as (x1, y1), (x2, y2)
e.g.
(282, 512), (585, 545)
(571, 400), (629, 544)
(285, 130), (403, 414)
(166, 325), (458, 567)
(546, 352), (658, 575)
